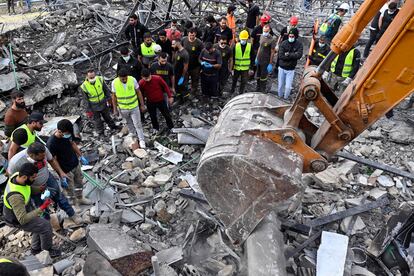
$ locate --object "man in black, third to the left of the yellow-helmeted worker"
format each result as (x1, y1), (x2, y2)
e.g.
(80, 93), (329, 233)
(181, 28), (204, 95)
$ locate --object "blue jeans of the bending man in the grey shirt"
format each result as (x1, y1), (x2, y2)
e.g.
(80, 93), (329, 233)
(32, 173), (75, 219)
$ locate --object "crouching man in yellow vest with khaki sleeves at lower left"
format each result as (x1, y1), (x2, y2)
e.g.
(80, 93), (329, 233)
(3, 163), (61, 258)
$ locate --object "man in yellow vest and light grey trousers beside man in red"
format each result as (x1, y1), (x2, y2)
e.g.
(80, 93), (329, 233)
(111, 69), (145, 149)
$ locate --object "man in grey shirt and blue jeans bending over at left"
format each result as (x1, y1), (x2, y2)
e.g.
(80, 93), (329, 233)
(7, 142), (82, 225)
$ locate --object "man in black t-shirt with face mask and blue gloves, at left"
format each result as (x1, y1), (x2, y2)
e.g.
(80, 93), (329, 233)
(47, 119), (92, 206)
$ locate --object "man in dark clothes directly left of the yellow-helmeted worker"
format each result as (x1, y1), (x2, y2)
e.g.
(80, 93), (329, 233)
(214, 37), (233, 95)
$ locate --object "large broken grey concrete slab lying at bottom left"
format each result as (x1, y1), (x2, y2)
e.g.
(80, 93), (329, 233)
(87, 224), (150, 261)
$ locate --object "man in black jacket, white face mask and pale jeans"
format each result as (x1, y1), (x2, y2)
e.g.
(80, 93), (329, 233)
(278, 28), (303, 99)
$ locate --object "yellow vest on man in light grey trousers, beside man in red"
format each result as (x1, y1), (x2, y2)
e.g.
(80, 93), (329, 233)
(114, 76), (138, 109)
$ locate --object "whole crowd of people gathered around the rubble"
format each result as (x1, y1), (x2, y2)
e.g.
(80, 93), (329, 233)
(0, 0), (404, 272)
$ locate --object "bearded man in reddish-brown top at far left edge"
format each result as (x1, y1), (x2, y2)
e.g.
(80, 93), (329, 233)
(4, 91), (28, 137)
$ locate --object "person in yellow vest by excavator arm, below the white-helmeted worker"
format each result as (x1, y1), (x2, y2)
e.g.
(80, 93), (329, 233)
(328, 46), (361, 94)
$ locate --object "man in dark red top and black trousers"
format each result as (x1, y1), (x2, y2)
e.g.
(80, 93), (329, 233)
(139, 68), (174, 131)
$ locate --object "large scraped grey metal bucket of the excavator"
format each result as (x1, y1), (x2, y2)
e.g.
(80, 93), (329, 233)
(197, 93), (303, 243)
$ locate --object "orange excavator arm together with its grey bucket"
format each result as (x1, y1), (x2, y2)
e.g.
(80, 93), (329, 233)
(197, 0), (414, 244)
